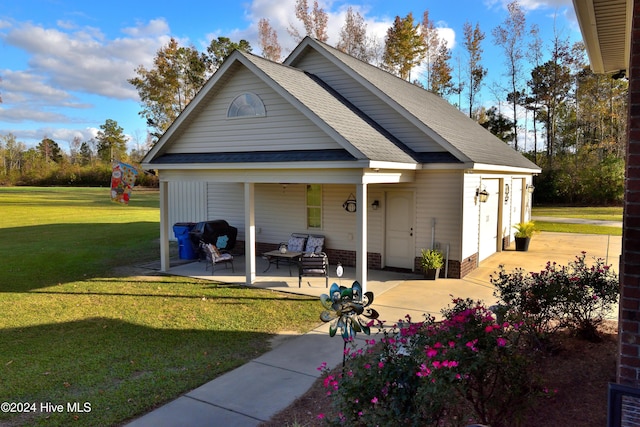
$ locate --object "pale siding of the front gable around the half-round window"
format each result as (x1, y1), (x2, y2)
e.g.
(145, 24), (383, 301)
(168, 67), (340, 153)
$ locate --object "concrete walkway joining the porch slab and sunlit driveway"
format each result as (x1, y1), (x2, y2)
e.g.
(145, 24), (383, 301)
(127, 232), (621, 427)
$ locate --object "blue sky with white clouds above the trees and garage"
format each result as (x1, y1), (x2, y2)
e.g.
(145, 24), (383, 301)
(0, 0), (580, 154)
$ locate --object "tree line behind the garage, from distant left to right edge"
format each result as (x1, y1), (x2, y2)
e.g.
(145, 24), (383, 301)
(0, 0), (627, 204)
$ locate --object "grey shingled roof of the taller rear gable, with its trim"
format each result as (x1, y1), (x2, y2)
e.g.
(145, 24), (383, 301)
(285, 37), (540, 171)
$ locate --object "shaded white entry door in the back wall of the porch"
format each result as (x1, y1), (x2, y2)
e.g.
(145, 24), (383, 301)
(385, 191), (415, 270)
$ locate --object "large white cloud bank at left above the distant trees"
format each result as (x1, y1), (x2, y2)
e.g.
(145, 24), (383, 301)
(0, 20), (169, 105)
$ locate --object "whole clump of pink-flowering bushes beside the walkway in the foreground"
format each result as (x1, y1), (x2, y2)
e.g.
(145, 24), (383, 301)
(324, 299), (532, 427)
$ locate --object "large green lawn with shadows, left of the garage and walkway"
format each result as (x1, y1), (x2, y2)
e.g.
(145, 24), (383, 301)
(0, 187), (321, 426)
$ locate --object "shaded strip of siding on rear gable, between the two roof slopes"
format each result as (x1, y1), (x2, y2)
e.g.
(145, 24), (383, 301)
(296, 51), (445, 152)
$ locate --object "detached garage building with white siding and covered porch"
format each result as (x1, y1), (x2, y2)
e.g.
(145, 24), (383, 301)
(143, 38), (540, 292)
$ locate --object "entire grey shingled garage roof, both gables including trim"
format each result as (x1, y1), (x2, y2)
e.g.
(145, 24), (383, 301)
(142, 38), (540, 172)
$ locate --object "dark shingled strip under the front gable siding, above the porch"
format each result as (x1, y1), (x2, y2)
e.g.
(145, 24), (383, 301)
(151, 149), (356, 165)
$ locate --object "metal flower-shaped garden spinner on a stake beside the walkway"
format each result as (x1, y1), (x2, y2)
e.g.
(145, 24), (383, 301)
(320, 281), (379, 368)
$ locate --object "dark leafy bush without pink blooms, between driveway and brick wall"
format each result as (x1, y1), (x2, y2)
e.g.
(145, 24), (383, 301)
(491, 252), (619, 343)
